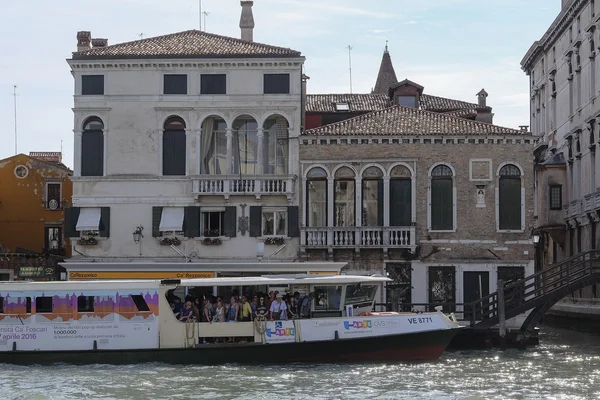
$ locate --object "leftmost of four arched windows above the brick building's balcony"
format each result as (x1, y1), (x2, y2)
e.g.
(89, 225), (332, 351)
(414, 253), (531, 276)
(306, 167), (327, 228)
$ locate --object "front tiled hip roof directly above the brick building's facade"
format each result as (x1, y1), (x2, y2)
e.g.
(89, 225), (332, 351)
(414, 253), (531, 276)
(304, 106), (523, 136)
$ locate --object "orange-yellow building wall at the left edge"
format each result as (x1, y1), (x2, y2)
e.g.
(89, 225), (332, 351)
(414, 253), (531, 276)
(0, 154), (73, 257)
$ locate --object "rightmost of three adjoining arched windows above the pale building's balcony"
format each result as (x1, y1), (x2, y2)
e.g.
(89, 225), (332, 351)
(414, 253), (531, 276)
(262, 115), (289, 175)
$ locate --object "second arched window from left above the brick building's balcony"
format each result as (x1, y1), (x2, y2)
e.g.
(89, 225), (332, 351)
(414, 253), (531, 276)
(333, 167), (356, 227)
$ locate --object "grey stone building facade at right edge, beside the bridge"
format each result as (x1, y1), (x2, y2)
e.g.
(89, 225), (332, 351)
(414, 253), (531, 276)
(521, 0), (600, 297)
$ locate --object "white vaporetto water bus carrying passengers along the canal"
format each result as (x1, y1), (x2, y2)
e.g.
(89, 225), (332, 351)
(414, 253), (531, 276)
(0, 274), (460, 364)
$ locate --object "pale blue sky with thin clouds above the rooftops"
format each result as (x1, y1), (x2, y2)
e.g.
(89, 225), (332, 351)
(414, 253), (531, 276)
(0, 0), (561, 167)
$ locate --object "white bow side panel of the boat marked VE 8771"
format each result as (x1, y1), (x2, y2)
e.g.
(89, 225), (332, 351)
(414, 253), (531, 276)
(297, 314), (447, 341)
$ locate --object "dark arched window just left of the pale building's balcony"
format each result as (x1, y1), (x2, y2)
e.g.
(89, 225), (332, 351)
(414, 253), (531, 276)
(163, 117), (186, 176)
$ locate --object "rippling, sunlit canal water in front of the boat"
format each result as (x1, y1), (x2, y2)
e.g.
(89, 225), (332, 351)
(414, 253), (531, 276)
(0, 326), (600, 400)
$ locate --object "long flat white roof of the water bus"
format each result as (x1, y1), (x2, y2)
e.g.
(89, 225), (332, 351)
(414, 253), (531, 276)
(0, 274), (391, 292)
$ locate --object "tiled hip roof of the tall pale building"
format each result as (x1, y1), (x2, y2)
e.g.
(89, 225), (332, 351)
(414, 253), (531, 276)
(73, 30), (301, 60)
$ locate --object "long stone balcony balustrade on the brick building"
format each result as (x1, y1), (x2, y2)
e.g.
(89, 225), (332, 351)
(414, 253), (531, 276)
(300, 226), (416, 250)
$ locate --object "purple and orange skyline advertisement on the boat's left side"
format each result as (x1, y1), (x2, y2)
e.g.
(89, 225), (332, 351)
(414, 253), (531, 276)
(0, 290), (159, 351)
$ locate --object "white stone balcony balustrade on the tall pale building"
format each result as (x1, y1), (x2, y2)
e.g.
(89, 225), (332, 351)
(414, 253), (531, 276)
(192, 175), (296, 200)
